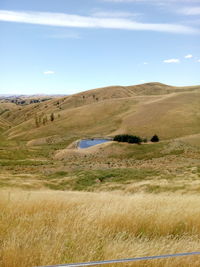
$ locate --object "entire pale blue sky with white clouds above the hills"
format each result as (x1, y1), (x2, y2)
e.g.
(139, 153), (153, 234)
(0, 0), (200, 94)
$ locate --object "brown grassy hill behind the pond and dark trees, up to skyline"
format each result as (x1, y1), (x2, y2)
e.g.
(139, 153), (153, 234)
(0, 83), (200, 141)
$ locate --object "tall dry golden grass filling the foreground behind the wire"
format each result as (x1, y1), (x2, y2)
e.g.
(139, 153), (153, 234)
(0, 191), (200, 267)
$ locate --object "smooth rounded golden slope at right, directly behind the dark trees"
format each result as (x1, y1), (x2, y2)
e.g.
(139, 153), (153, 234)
(118, 92), (200, 139)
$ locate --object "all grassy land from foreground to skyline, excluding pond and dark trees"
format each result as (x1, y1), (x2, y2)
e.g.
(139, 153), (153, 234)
(0, 83), (200, 267)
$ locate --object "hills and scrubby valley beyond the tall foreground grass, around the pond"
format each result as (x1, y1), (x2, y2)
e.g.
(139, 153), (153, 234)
(0, 83), (200, 193)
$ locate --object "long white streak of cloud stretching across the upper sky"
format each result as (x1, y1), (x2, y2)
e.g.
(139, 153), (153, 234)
(0, 10), (199, 34)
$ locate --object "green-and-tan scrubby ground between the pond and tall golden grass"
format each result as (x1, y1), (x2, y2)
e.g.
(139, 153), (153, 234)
(0, 140), (200, 193)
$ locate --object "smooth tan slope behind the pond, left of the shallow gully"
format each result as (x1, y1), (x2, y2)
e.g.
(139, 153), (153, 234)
(5, 99), (136, 140)
